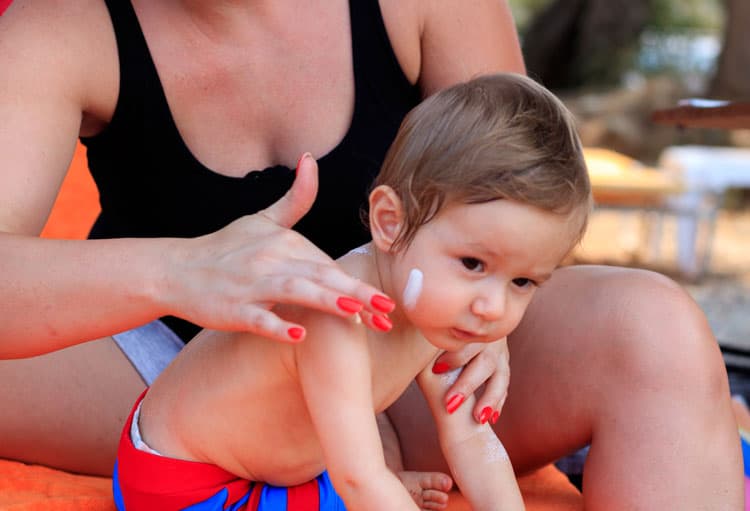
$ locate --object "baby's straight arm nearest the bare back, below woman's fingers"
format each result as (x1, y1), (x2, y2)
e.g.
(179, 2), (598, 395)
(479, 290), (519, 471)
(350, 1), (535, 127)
(295, 314), (418, 511)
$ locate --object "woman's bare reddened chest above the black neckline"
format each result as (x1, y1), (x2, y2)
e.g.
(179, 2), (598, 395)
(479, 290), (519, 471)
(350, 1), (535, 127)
(136, 0), (355, 177)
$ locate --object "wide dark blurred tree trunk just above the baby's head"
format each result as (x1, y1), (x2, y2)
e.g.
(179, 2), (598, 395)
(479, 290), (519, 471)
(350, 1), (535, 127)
(523, 0), (652, 89)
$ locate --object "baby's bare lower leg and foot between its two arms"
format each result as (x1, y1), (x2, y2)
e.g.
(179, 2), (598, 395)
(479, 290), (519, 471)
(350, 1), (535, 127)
(377, 413), (453, 511)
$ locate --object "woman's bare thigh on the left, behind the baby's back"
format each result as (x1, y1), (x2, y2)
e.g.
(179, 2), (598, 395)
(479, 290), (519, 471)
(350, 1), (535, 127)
(0, 338), (145, 475)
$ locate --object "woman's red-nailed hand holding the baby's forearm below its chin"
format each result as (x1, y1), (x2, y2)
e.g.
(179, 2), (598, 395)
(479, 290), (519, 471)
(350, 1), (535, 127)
(432, 337), (510, 424)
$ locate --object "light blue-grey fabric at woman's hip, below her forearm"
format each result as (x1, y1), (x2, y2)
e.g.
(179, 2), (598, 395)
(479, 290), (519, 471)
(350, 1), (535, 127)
(112, 319), (185, 385)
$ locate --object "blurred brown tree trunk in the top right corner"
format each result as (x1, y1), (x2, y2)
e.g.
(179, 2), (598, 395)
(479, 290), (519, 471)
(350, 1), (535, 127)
(710, 0), (750, 100)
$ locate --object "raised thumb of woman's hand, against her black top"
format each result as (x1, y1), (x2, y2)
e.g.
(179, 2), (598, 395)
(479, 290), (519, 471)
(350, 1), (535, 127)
(261, 153), (318, 227)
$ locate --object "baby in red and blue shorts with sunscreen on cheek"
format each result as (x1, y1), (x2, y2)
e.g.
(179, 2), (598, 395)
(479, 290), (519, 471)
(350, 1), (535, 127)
(114, 74), (591, 511)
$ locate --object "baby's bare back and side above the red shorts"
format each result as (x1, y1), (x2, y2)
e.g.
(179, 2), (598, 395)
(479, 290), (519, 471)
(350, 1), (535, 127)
(140, 331), (324, 486)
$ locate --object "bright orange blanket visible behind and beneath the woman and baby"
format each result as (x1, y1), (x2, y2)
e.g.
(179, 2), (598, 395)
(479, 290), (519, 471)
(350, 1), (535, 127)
(10, 145), (583, 511)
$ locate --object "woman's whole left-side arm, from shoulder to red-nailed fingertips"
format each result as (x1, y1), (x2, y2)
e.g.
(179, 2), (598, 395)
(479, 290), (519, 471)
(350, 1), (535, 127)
(0, 0), (396, 358)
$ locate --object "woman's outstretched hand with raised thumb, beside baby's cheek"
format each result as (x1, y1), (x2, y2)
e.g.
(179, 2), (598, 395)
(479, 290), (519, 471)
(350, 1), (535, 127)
(159, 154), (394, 342)
